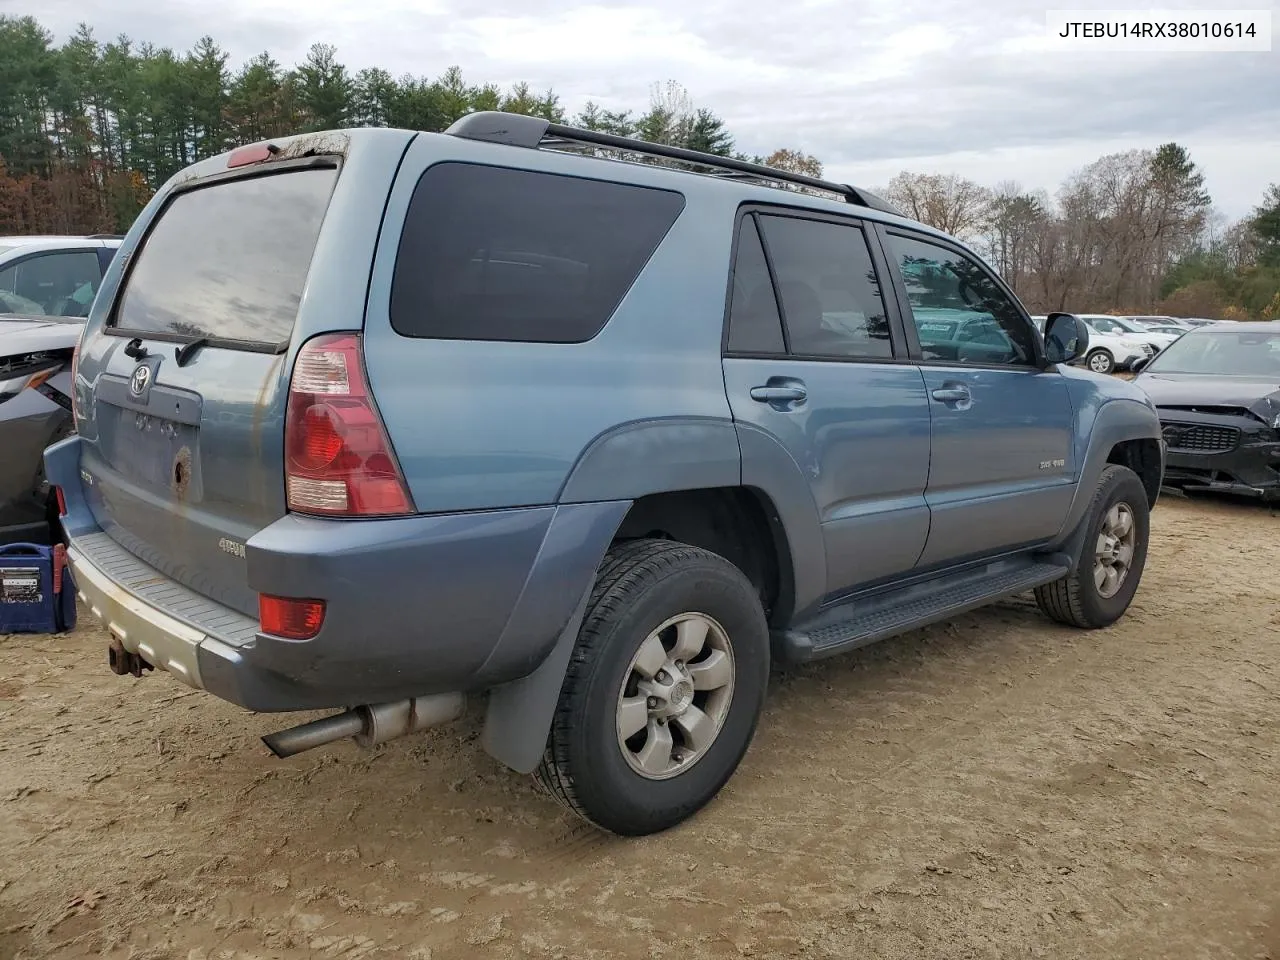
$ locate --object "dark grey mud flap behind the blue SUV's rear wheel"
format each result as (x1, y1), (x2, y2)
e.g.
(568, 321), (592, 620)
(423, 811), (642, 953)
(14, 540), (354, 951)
(480, 584), (594, 773)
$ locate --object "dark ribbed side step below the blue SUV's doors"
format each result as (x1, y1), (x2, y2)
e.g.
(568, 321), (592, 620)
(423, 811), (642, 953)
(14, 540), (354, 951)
(773, 557), (1069, 663)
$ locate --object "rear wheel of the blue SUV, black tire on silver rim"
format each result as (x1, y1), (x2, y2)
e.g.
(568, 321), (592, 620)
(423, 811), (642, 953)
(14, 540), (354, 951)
(535, 540), (769, 836)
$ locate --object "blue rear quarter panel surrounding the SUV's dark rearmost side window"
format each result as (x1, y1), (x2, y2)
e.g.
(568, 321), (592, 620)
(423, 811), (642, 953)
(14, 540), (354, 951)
(365, 134), (740, 512)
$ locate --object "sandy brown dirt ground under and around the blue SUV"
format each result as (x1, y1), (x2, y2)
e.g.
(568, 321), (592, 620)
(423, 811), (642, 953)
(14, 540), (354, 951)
(0, 497), (1280, 960)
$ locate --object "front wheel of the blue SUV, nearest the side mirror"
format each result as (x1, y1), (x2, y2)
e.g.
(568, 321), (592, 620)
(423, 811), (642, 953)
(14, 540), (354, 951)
(1036, 466), (1151, 630)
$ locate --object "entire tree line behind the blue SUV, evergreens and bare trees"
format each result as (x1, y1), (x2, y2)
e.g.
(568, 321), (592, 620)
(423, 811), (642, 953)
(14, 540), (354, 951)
(0, 15), (1280, 316)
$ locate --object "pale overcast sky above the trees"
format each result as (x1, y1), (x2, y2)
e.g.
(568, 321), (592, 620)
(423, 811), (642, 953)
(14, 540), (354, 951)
(22, 0), (1280, 218)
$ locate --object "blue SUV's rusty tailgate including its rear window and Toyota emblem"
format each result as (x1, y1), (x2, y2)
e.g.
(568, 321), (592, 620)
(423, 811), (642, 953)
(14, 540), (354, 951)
(78, 164), (335, 614)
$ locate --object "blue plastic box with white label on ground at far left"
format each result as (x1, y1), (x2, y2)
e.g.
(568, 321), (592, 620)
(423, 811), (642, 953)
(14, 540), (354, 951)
(0, 543), (76, 634)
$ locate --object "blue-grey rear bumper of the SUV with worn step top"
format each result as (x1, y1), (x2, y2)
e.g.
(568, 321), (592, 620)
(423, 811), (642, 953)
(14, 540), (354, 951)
(46, 438), (630, 712)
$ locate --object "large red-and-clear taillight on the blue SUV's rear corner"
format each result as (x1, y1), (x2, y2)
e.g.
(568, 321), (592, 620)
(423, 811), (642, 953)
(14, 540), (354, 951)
(284, 333), (413, 517)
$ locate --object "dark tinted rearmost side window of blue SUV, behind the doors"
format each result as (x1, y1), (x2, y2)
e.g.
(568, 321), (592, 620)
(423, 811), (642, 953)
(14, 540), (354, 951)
(390, 163), (685, 343)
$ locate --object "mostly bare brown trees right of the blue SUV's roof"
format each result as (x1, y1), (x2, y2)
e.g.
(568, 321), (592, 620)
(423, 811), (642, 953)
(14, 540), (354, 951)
(884, 158), (1280, 320)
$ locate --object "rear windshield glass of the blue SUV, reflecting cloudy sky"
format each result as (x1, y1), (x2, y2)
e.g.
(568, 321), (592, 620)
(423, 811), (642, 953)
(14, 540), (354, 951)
(114, 168), (338, 344)
